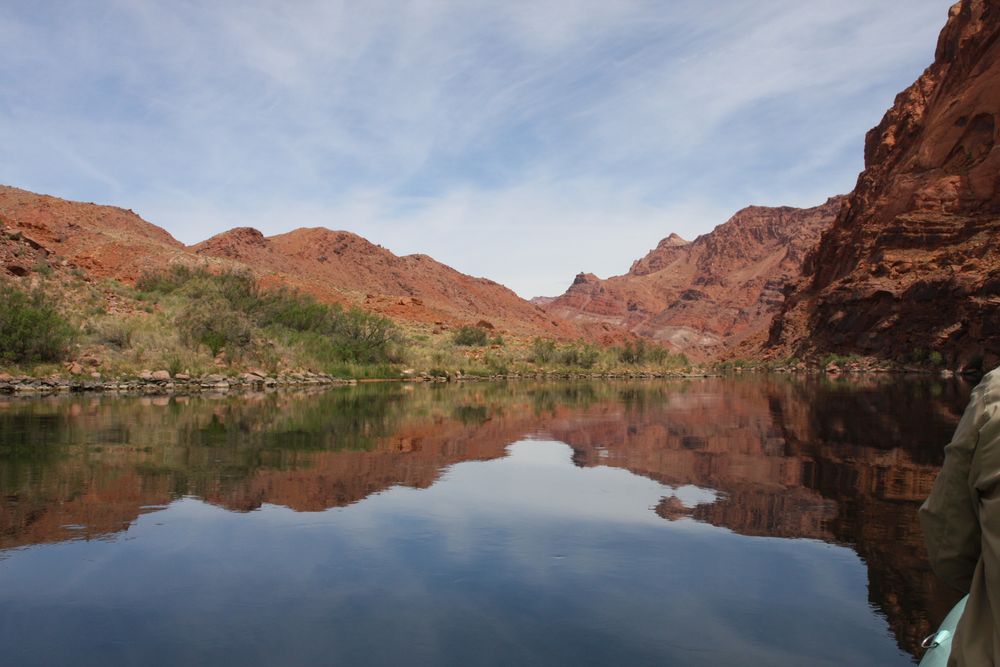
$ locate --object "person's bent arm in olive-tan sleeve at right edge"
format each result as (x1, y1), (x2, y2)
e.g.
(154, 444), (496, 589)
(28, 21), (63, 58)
(920, 371), (1000, 593)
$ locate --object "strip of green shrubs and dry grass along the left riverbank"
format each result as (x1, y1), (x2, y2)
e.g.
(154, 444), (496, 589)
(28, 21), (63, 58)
(0, 266), (689, 379)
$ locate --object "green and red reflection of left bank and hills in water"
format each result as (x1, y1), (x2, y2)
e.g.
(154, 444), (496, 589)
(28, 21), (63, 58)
(0, 385), (533, 548)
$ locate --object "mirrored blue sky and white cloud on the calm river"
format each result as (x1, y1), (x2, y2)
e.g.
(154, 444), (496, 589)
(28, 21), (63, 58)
(0, 441), (909, 666)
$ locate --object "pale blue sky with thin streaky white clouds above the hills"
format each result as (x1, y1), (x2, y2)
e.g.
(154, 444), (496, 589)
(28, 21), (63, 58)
(0, 0), (951, 297)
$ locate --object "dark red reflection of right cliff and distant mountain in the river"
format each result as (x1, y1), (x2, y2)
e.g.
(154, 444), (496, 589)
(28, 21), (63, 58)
(548, 382), (968, 653)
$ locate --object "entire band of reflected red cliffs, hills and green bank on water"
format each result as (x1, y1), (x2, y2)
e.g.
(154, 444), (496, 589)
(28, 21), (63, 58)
(0, 379), (968, 651)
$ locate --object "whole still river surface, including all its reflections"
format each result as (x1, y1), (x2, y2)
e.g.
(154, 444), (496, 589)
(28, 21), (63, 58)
(0, 378), (970, 666)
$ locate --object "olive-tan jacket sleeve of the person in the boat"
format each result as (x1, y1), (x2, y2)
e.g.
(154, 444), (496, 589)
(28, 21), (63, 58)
(920, 369), (1000, 593)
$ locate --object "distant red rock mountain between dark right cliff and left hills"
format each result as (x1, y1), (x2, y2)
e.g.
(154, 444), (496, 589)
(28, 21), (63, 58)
(545, 197), (842, 360)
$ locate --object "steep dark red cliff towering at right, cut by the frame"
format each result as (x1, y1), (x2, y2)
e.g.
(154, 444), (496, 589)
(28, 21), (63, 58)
(769, 0), (1000, 366)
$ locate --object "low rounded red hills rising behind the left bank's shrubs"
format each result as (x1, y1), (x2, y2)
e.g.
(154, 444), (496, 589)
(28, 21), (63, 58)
(0, 186), (584, 338)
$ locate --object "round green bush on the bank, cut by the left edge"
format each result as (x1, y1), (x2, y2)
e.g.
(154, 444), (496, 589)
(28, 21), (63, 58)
(0, 285), (74, 364)
